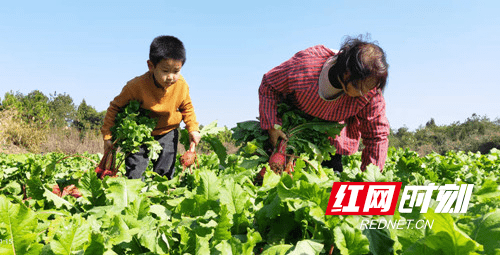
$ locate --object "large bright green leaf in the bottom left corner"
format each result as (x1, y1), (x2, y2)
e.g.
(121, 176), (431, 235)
(0, 195), (43, 255)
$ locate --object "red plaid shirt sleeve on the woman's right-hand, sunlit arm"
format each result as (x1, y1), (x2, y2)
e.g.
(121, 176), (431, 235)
(358, 92), (390, 170)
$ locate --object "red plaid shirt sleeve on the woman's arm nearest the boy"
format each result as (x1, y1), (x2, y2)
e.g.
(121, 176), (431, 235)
(259, 58), (293, 130)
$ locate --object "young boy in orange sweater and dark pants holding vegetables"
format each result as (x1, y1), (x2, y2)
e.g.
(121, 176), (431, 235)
(101, 36), (201, 179)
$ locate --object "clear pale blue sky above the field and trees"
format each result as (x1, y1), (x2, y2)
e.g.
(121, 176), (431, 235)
(0, 0), (500, 130)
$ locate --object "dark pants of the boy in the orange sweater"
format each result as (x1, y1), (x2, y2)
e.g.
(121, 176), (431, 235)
(125, 129), (179, 180)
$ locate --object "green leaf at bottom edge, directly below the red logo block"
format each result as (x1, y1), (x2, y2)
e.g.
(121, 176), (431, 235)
(334, 223), (370, 255)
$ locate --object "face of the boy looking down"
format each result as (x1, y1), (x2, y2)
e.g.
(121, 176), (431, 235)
(148, 58), (182, 88)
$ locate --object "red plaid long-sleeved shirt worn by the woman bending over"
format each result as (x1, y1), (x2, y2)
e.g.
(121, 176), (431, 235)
(259, 45), (390, 169)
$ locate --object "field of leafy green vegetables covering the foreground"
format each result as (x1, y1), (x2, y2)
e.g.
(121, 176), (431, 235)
(0, 142), (500, 255)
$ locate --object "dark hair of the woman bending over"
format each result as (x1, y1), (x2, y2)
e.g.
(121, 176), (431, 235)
(328, 35), (389, 91)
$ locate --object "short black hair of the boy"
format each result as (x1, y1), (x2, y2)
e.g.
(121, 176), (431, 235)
(149, 35), (186, 66)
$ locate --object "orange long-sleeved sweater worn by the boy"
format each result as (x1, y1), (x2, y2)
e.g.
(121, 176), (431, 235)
(101, 72), (199, 140)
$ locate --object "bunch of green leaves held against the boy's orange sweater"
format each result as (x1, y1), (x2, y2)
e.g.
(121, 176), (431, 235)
(111, 100), (162, 160)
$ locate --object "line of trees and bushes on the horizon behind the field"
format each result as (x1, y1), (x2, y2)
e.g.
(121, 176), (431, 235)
(0, 90), (500, 155)
